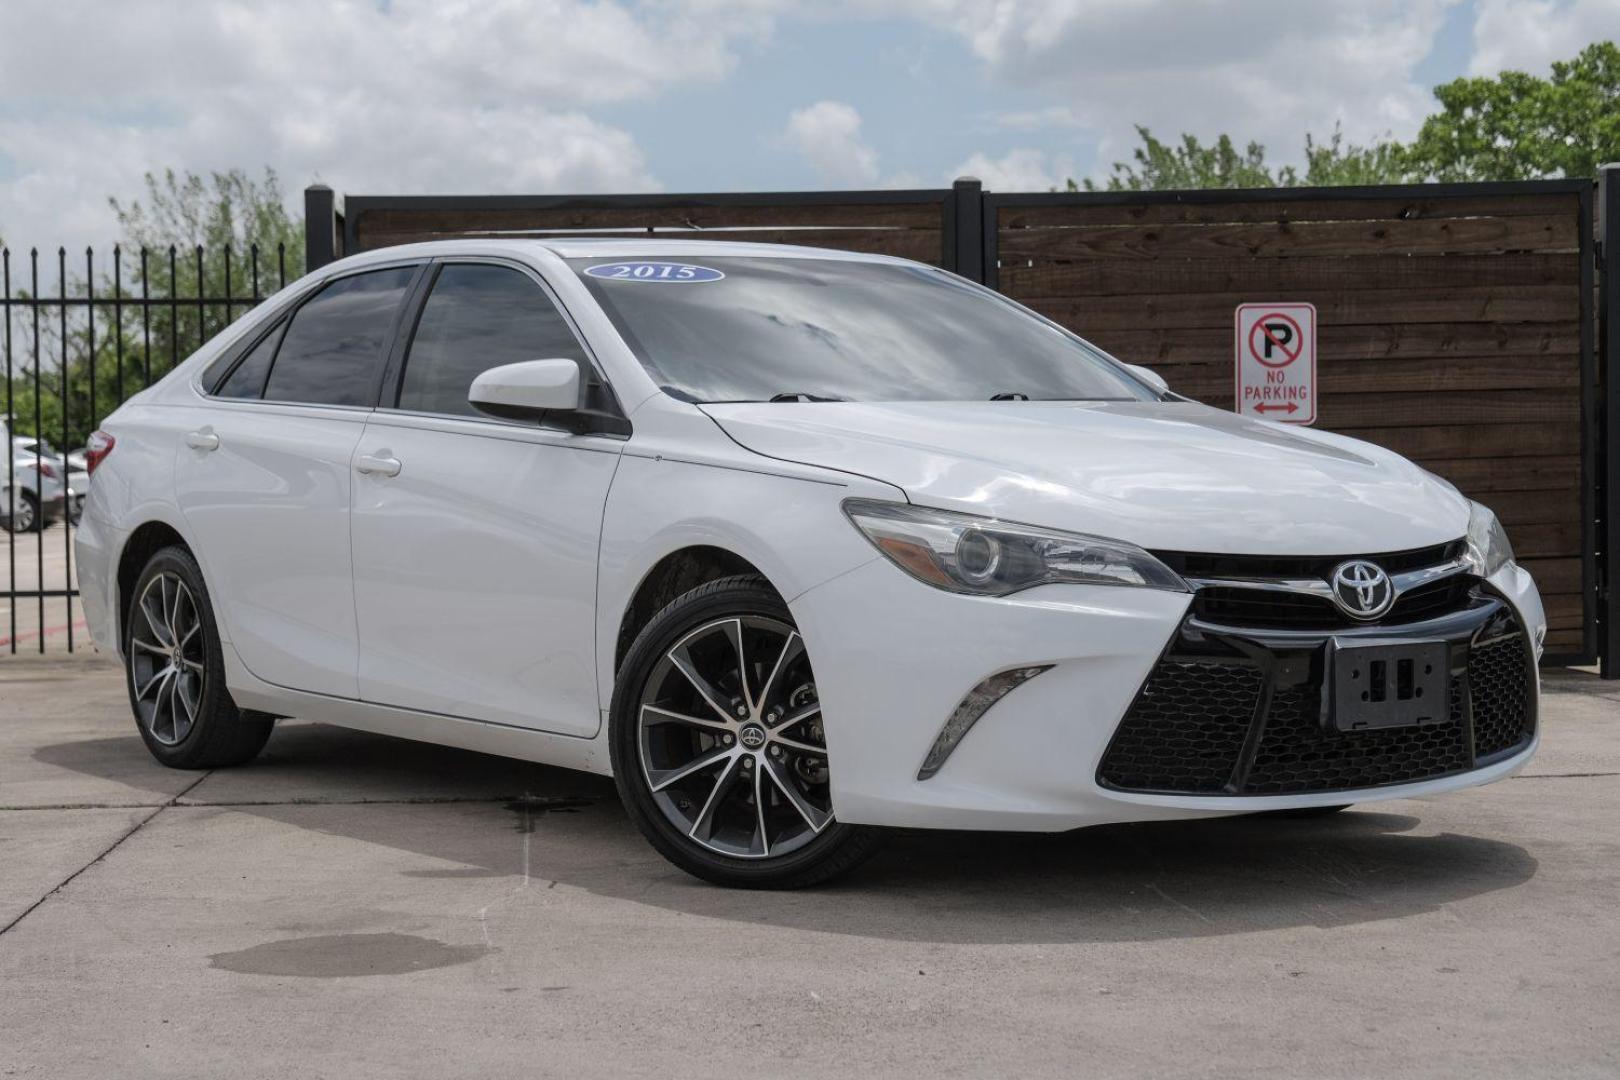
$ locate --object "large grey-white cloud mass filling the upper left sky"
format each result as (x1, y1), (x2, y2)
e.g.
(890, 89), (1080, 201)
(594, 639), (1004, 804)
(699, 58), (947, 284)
(0, 0), (770, 248)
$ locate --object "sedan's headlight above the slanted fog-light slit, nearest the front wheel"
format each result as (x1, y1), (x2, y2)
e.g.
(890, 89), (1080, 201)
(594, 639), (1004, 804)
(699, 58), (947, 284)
(844, 499), (1187, 596)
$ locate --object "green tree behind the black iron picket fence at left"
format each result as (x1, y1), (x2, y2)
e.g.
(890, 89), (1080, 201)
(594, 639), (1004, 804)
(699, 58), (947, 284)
(0, 170), (305, 449)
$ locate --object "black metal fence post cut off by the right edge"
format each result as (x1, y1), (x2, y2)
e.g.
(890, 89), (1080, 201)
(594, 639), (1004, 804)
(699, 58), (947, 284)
(1597, 162), (1620, 678)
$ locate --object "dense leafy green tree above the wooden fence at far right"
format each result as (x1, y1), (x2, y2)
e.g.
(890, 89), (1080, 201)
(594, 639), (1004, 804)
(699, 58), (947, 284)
(1403, 40), (1620, 181)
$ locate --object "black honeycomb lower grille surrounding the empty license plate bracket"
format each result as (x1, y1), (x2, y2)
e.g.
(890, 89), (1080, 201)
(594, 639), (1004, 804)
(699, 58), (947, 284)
(1098, 591), (1534, 795)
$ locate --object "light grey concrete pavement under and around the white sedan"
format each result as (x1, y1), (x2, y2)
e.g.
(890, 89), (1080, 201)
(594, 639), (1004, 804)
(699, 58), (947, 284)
(0, 656), (1620, 1080)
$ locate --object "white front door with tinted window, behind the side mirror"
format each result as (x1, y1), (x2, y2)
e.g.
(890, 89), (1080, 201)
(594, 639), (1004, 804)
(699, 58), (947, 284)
(353, 261), (622, 735)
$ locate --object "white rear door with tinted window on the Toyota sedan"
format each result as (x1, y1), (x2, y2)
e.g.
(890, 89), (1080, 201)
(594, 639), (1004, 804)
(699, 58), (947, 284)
(175, 264), (423, 698)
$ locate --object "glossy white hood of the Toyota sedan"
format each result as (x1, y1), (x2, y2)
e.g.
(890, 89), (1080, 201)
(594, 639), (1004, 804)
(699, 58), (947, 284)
(703, 402), (1468, 555)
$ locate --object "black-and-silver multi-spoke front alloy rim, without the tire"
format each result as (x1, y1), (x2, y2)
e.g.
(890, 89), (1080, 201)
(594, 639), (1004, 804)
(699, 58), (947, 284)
(638, 615), (833, 858)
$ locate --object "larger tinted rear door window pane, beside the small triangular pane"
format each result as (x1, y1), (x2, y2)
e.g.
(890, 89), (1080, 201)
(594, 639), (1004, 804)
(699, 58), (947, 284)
(264, 267), (416, 406)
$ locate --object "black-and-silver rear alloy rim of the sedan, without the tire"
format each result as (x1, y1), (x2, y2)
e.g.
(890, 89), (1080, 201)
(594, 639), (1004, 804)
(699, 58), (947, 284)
(130, 572), (207, 746)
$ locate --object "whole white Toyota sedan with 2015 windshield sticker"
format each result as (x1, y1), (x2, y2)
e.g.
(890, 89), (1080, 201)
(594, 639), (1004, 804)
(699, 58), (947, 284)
(78, 238), (1545, 887)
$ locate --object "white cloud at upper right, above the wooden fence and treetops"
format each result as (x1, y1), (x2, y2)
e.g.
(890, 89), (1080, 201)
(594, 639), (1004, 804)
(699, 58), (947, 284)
(886, 0), (1458, 172)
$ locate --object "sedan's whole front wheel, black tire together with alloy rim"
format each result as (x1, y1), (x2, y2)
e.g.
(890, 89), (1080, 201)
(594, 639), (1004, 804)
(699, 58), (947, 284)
(609, 575), (876, 889)
